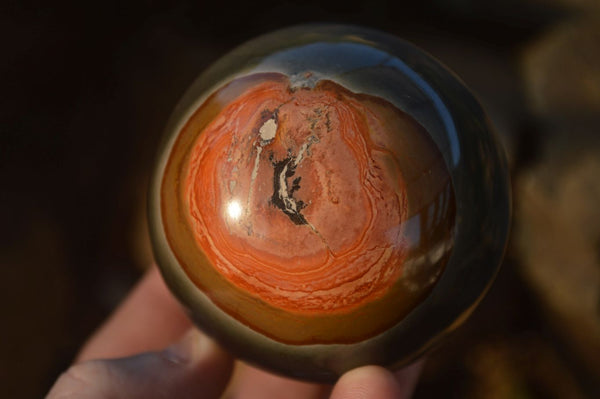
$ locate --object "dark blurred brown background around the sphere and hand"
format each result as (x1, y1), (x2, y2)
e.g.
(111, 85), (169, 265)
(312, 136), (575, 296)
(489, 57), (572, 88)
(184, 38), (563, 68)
(0, 0), (600, 398)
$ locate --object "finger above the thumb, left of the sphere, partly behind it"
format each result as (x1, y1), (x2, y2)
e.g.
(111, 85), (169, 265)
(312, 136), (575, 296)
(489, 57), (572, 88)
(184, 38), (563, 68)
(77, 267), (191, 361)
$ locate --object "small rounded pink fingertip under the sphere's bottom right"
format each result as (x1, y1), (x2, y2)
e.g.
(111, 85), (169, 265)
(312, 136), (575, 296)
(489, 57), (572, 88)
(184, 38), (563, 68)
(331, 366), (407, 399)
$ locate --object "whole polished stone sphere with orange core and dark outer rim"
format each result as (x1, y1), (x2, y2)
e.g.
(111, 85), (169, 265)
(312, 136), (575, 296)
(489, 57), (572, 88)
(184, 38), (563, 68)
(150, 25), (510, 381)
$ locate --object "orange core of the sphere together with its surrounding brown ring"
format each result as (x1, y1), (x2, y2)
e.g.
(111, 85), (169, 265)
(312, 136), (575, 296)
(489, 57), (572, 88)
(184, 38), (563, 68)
(161, 73), (455, 344)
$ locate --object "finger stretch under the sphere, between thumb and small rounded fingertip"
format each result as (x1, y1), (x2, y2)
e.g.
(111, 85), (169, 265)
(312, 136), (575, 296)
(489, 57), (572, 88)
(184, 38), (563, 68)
(223, 362), (331, 399)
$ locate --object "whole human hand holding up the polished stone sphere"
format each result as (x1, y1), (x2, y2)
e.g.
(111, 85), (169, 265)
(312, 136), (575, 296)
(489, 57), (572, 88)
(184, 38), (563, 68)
(47, 268), (421, 399)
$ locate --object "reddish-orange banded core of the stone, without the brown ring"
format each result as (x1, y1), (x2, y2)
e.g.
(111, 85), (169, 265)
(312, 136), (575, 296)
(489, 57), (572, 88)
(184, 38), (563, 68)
(185, 75), (406, 312)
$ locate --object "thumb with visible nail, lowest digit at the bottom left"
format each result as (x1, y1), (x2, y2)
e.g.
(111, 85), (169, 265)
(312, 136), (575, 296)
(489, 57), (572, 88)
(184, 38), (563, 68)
(47, 329), (232, 399)
